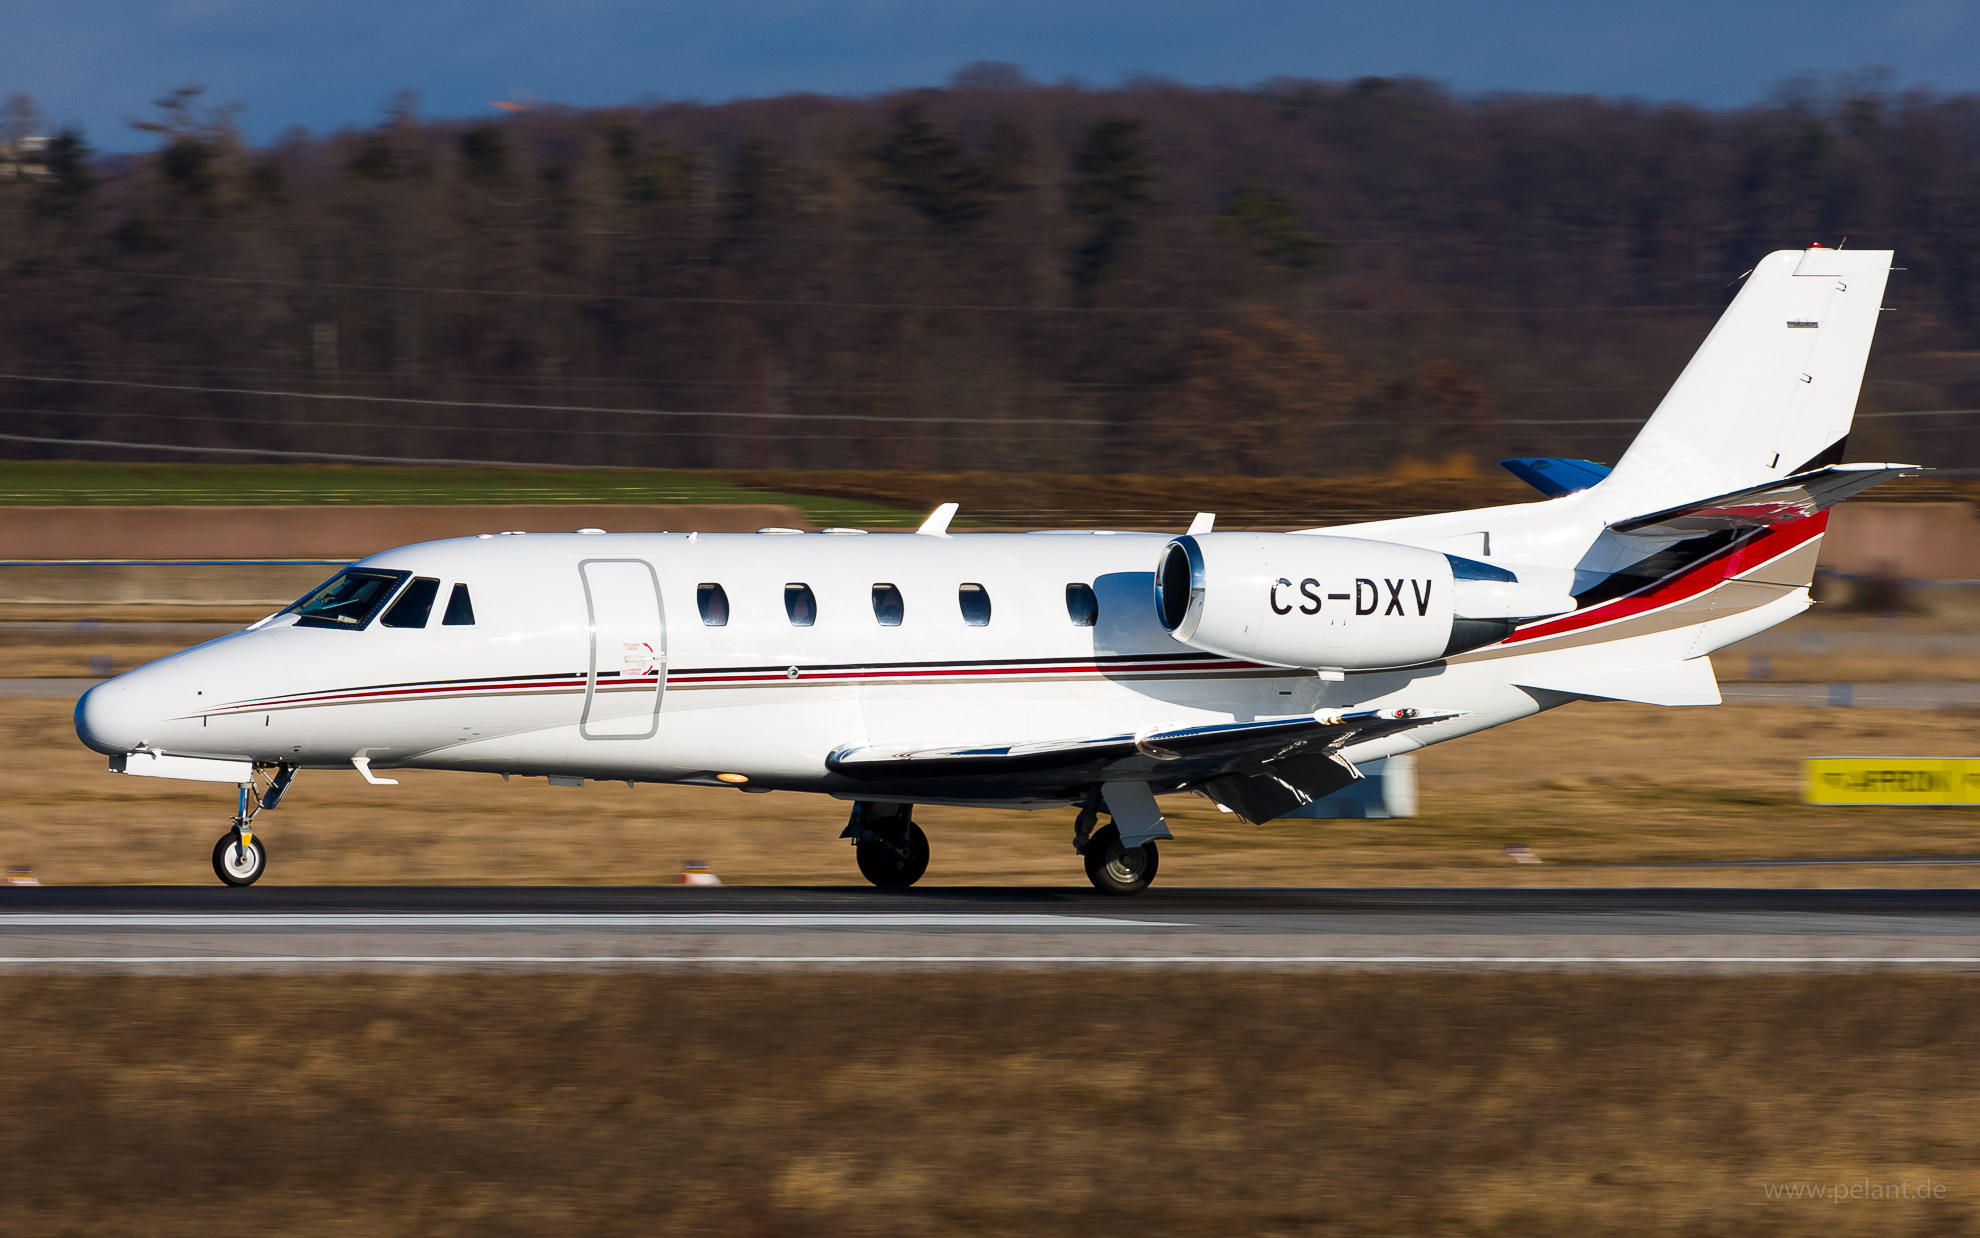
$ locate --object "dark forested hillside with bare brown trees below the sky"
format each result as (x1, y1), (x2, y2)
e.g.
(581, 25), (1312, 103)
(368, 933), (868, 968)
(0, 65), (1980, 475)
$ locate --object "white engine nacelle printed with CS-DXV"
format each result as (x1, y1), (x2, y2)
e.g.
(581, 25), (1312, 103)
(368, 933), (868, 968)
(1154, 533), (1574, 670)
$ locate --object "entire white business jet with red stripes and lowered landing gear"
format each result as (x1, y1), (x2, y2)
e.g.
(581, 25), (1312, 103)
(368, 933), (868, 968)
(75, 246), (1915, 895)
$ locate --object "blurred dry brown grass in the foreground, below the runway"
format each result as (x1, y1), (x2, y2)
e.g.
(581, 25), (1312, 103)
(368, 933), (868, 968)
(0, 973), (1980, 1238)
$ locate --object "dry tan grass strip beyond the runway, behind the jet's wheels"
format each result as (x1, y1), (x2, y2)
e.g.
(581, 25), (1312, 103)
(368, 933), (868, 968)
(0, 699), (1980, 885)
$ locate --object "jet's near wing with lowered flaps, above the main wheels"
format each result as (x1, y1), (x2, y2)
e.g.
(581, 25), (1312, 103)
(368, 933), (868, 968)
(826, 709), (1455, 820)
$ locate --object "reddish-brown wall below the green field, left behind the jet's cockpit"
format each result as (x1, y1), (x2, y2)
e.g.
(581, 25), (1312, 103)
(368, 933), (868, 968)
(0, 503), (806, 561)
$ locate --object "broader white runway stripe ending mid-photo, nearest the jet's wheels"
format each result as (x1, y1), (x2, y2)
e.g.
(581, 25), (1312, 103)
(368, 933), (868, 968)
(0, 911), (1182, 933)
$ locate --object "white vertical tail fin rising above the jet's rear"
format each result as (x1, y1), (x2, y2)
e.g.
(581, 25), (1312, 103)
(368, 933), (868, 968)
(1596, 248), (1891, 517)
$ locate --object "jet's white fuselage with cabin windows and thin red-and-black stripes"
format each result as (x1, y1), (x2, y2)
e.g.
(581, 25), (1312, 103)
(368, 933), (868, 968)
(77, 533), (1806, 806)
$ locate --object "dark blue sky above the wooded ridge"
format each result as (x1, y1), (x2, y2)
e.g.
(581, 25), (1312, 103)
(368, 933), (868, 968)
(0, 0), (1980, 149)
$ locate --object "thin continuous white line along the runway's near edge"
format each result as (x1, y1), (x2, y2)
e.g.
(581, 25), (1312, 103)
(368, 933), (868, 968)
(0, 955), (1980, 969)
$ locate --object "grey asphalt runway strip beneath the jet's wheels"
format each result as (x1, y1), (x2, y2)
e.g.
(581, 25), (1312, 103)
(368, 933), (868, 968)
(11, 885), (1980, 973)
